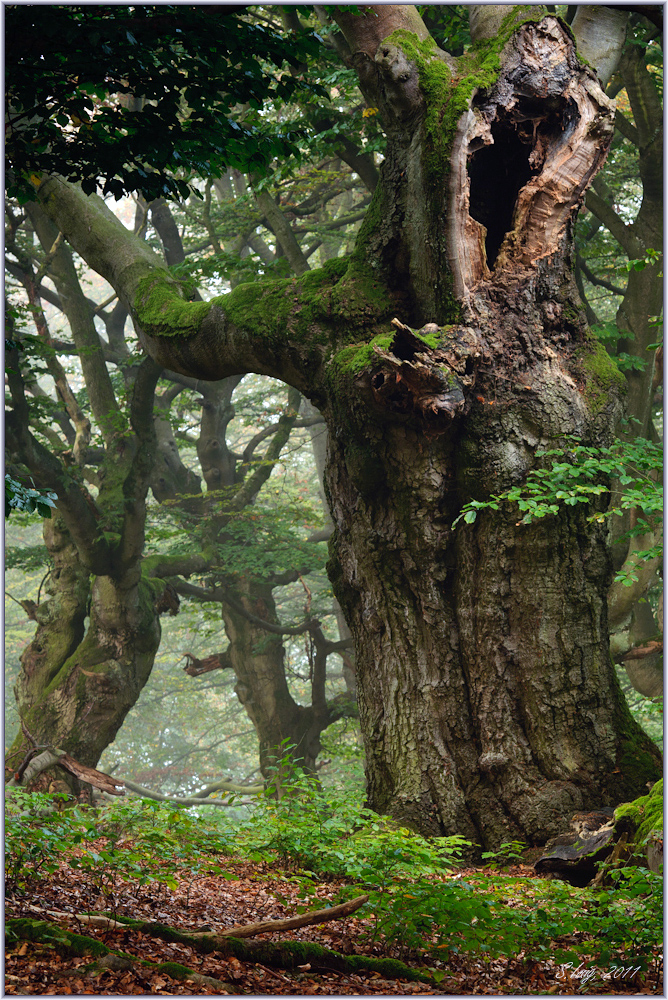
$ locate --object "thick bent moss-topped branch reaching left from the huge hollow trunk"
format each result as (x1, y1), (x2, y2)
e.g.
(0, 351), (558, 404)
(38, 177), (374, 395)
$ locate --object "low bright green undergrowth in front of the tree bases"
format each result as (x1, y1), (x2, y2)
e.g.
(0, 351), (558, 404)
(5, 778), (663, 978)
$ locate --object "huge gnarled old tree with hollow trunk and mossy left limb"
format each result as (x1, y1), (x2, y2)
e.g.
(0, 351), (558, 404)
(39, 6), (660, 845)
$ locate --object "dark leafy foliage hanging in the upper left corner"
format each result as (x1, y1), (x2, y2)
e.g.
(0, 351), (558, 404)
(5, 4), (326, 200)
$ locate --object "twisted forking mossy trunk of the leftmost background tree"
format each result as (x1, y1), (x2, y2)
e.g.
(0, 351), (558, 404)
(7, 359), (163, 780)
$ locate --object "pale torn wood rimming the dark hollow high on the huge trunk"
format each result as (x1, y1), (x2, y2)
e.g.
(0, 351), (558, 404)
(448, 17), (614, 300)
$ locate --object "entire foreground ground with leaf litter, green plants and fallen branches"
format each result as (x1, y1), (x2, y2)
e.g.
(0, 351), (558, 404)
(5, 796), (663, 996)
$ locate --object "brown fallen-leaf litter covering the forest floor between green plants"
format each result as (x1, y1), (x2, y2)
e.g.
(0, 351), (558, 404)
(5, 860), (663, 996)
